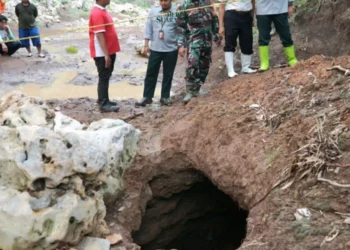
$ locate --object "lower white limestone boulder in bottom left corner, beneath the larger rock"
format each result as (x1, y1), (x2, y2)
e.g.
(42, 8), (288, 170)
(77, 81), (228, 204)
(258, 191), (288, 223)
(0, 187), (106, 250)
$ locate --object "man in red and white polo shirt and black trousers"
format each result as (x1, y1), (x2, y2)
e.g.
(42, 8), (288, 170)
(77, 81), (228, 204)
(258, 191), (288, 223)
(89, 0), (120, 112)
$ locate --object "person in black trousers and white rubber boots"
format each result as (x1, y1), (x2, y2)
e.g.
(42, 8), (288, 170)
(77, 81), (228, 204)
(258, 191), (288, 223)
(219, 0), (256, 78)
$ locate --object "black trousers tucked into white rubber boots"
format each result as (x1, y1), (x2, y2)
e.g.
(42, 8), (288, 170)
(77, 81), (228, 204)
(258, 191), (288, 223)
(224, 10), (253, 55)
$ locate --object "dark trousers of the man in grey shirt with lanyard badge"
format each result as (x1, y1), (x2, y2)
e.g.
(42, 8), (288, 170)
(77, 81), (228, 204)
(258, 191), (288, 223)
(143, 50), (178, 99)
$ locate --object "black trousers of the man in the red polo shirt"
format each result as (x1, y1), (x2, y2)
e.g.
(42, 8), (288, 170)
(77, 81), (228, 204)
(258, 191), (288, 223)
(94, 54), (116, 103)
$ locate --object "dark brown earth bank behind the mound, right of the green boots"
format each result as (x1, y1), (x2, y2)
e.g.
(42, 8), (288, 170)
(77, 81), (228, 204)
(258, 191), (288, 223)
(294, 0), (350, 58)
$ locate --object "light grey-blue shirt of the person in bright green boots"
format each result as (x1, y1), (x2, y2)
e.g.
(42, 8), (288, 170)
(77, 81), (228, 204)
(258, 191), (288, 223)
(256, 0), (294, 15)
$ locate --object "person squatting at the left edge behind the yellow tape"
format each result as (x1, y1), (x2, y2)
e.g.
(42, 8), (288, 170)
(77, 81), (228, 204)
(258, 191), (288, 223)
(0, 15), (21, 56)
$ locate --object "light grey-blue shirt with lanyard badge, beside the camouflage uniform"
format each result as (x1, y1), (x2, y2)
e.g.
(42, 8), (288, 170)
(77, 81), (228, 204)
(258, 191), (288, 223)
(145, 5), (178, 52)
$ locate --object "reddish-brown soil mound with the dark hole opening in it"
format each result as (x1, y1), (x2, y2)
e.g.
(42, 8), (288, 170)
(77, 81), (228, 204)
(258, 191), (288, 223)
(47, 56), (350, 250)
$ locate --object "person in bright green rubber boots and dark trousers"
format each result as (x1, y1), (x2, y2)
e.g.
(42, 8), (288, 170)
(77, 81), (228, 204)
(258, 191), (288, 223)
(256, 0), (298, 72)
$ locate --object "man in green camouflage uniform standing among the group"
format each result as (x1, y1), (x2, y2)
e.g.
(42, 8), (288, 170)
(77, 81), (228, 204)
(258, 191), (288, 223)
(177, 0), (221, 104)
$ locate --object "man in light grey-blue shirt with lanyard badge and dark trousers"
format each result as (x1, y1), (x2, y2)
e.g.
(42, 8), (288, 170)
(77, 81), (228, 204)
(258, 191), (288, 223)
(136, 0), (178, 106)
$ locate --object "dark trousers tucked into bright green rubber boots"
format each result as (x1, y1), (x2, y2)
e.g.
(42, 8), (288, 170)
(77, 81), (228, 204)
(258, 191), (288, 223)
(256, 13), (294, 47)
